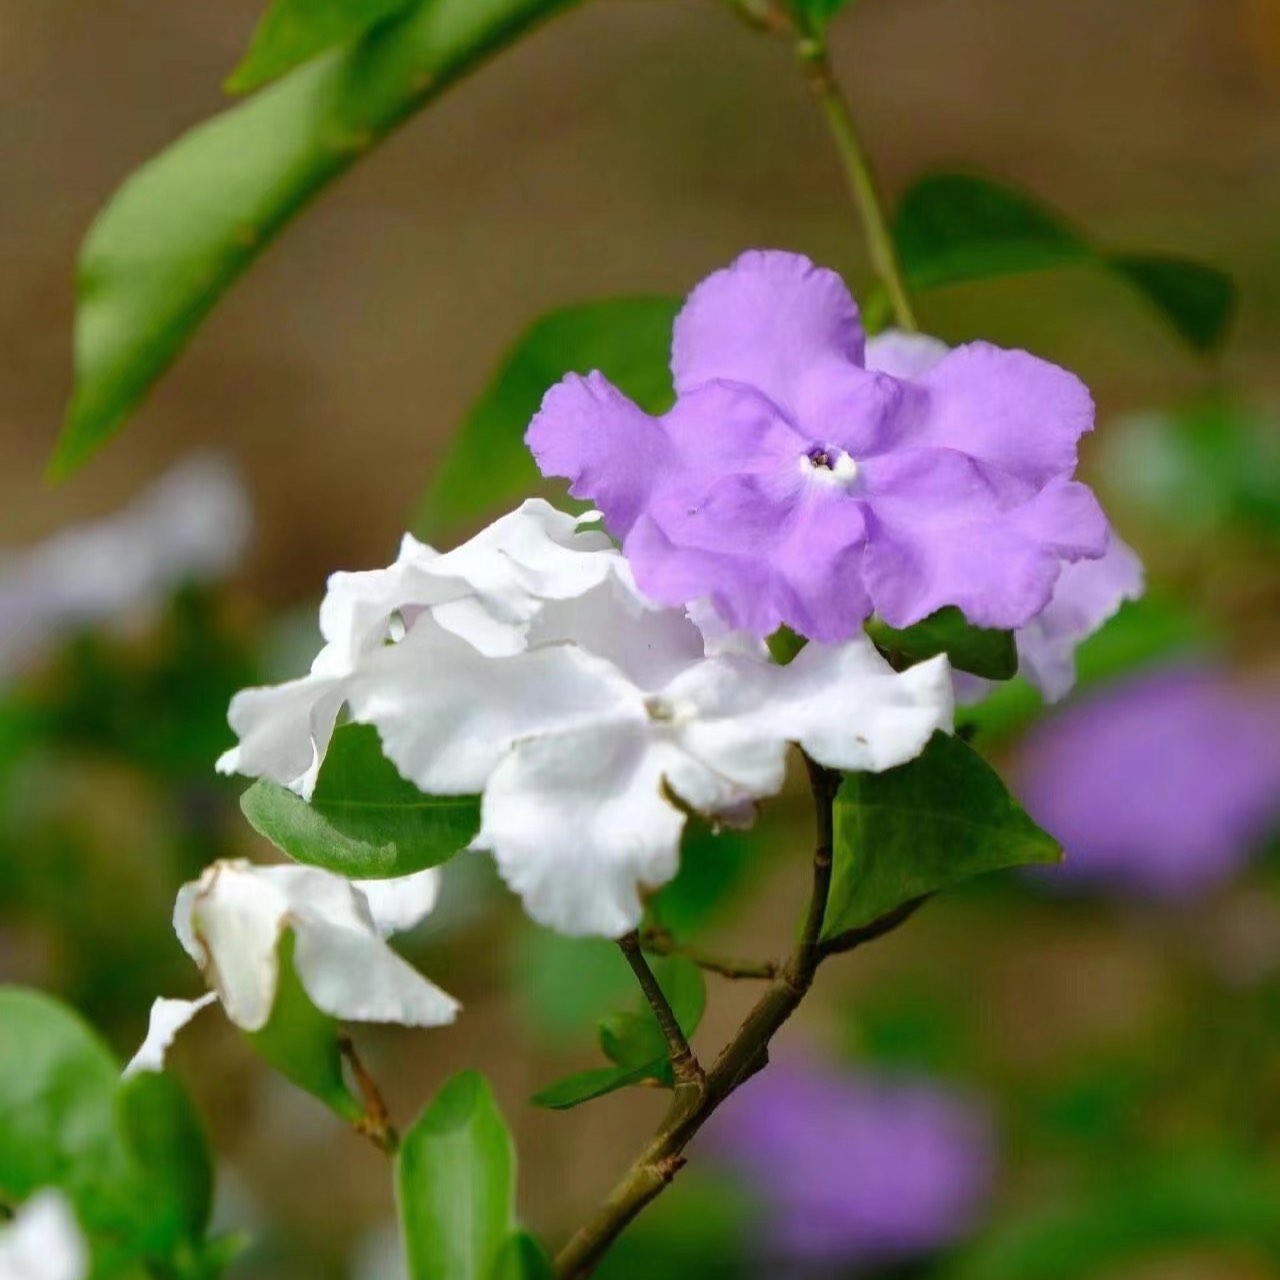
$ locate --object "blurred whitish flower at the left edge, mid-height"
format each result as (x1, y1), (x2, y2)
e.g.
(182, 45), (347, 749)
(0, 456), (250, 676)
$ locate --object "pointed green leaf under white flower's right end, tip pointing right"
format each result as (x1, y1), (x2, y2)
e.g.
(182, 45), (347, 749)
(823, 733), (1061, 937)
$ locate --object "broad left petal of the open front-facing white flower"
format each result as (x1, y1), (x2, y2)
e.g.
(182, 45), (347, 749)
(348, 618), (639, 795)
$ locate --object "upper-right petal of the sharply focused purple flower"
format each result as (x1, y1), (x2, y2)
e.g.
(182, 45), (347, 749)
(904, 342), (1093, 485)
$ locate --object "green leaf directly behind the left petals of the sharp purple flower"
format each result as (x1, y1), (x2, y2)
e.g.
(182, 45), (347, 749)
(413, 297), (680, 540)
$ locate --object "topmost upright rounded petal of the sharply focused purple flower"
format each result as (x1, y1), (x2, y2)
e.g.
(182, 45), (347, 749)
(671, 250), (864, 421)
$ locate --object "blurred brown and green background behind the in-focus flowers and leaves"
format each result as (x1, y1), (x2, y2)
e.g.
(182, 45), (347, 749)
(0, 0), (1280, 1280)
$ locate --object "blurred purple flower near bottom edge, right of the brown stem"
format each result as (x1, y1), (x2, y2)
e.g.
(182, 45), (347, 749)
(708, 1061), (995, 1268)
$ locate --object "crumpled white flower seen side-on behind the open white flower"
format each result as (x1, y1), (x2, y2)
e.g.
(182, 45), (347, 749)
(218, 499), (626, 797)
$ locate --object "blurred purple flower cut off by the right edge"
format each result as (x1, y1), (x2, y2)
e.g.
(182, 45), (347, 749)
(1016, 667), (1280, 899)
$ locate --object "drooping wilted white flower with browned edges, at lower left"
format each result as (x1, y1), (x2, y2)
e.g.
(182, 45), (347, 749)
(125, 861), (458, 1075)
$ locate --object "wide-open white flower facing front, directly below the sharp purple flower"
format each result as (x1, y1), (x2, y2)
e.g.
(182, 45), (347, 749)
(348, 577), (951, 937)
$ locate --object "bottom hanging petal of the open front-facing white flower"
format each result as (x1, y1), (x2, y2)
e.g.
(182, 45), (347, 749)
(475, 721), (685, 938)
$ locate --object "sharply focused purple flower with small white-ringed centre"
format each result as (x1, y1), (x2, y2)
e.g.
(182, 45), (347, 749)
(527, 252), (1106, 643)
